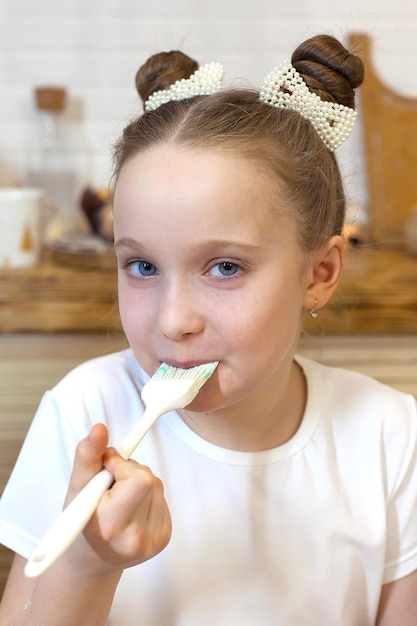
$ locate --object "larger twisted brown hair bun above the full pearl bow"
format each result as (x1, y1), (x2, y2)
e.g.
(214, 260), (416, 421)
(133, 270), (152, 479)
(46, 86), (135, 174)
(291, 35), (364, 109)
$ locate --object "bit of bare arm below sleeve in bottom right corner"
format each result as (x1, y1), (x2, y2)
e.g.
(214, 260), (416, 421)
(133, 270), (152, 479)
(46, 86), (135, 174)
(376, 571), (417, 626)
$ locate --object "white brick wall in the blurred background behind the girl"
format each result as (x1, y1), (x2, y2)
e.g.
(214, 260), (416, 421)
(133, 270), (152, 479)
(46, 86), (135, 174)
(0, 0), (417, 210)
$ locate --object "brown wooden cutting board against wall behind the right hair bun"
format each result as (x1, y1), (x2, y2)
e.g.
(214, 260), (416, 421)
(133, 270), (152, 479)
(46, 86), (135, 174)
(349, 33), (417, 242)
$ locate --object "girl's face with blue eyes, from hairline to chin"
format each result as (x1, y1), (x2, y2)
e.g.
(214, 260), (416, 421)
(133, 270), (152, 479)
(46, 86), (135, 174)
(114, 145), (312, 412)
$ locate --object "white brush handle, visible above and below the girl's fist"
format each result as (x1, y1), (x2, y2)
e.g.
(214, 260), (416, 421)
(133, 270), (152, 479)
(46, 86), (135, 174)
(25, 409), (161, 578)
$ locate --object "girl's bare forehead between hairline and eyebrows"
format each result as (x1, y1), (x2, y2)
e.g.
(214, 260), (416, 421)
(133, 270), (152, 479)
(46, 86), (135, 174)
(114, 145), (296, 254)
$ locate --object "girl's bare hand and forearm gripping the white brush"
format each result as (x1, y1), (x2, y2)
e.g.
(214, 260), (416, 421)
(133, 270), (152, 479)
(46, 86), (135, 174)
(0, 425), (171, 626)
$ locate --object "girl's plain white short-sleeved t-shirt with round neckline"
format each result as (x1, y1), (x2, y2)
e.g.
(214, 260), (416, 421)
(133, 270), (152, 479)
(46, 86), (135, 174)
(0, 350), (417, 626)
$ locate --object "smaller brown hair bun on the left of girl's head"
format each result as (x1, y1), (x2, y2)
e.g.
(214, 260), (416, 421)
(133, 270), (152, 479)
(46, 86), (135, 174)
(135, 50), (198, 102)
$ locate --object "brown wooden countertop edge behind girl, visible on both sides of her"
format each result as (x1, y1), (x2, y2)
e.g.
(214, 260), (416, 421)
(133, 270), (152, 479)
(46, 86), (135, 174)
(0, 245), (417, 334)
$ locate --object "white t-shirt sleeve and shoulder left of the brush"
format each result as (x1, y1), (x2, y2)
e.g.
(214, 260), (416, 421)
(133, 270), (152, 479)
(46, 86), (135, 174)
(0, 350), (145, 558)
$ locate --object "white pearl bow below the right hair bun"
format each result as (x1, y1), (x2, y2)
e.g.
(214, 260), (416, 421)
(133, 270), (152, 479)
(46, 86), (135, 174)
(259, 63), (356, 152)
